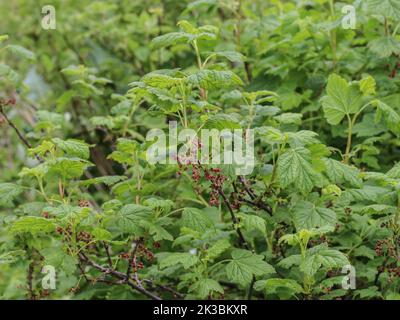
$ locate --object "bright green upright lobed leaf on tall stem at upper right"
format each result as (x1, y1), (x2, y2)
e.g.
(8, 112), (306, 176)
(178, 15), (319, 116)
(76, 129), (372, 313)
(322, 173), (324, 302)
(322, 74), (362, 125)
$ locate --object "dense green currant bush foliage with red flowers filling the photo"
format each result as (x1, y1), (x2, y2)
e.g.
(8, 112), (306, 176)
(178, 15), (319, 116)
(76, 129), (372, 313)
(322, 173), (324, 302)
(0, 0), (400, 299)
